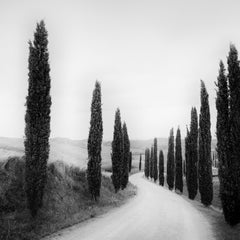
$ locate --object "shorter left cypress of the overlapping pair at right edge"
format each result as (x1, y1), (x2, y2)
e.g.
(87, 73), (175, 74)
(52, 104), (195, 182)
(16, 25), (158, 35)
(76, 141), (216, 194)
(216, 61), (232, 223)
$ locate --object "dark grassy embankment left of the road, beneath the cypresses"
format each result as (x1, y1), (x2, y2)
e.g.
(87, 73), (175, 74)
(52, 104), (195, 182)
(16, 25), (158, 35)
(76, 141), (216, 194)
(0, 158), (136, 240)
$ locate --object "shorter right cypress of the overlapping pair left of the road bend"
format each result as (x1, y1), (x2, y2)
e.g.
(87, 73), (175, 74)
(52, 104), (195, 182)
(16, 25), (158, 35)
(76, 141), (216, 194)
(121, 122), (130, 189)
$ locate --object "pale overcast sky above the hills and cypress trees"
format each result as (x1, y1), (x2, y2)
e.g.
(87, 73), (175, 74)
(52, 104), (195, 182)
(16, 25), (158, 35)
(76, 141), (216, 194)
(0, 0), (240, 140)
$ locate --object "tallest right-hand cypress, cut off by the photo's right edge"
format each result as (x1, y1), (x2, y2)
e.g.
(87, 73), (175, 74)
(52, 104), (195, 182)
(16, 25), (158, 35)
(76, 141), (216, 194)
(225, 45), (240, 225)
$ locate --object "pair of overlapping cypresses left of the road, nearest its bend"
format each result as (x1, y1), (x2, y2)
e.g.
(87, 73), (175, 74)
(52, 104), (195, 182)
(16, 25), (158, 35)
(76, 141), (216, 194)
(111, 108), (132, 192)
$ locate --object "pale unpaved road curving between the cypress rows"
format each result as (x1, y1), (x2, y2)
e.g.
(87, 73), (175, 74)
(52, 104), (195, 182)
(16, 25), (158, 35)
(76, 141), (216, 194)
(48, 173), (214, 240)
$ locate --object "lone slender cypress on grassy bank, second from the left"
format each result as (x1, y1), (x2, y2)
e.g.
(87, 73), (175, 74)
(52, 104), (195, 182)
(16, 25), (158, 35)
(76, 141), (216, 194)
(87, 81), (103, 200)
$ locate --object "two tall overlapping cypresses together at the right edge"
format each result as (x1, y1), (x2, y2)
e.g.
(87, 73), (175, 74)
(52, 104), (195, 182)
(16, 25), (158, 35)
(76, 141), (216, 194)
(216, 45), (240, 225)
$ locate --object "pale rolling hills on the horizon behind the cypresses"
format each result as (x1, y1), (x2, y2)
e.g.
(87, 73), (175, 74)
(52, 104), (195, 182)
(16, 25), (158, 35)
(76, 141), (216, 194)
(0, 137), (216, 168)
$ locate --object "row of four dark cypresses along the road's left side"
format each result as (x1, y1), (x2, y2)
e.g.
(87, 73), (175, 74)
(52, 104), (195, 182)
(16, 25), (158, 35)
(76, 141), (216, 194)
(24, 21), (132, 217)
